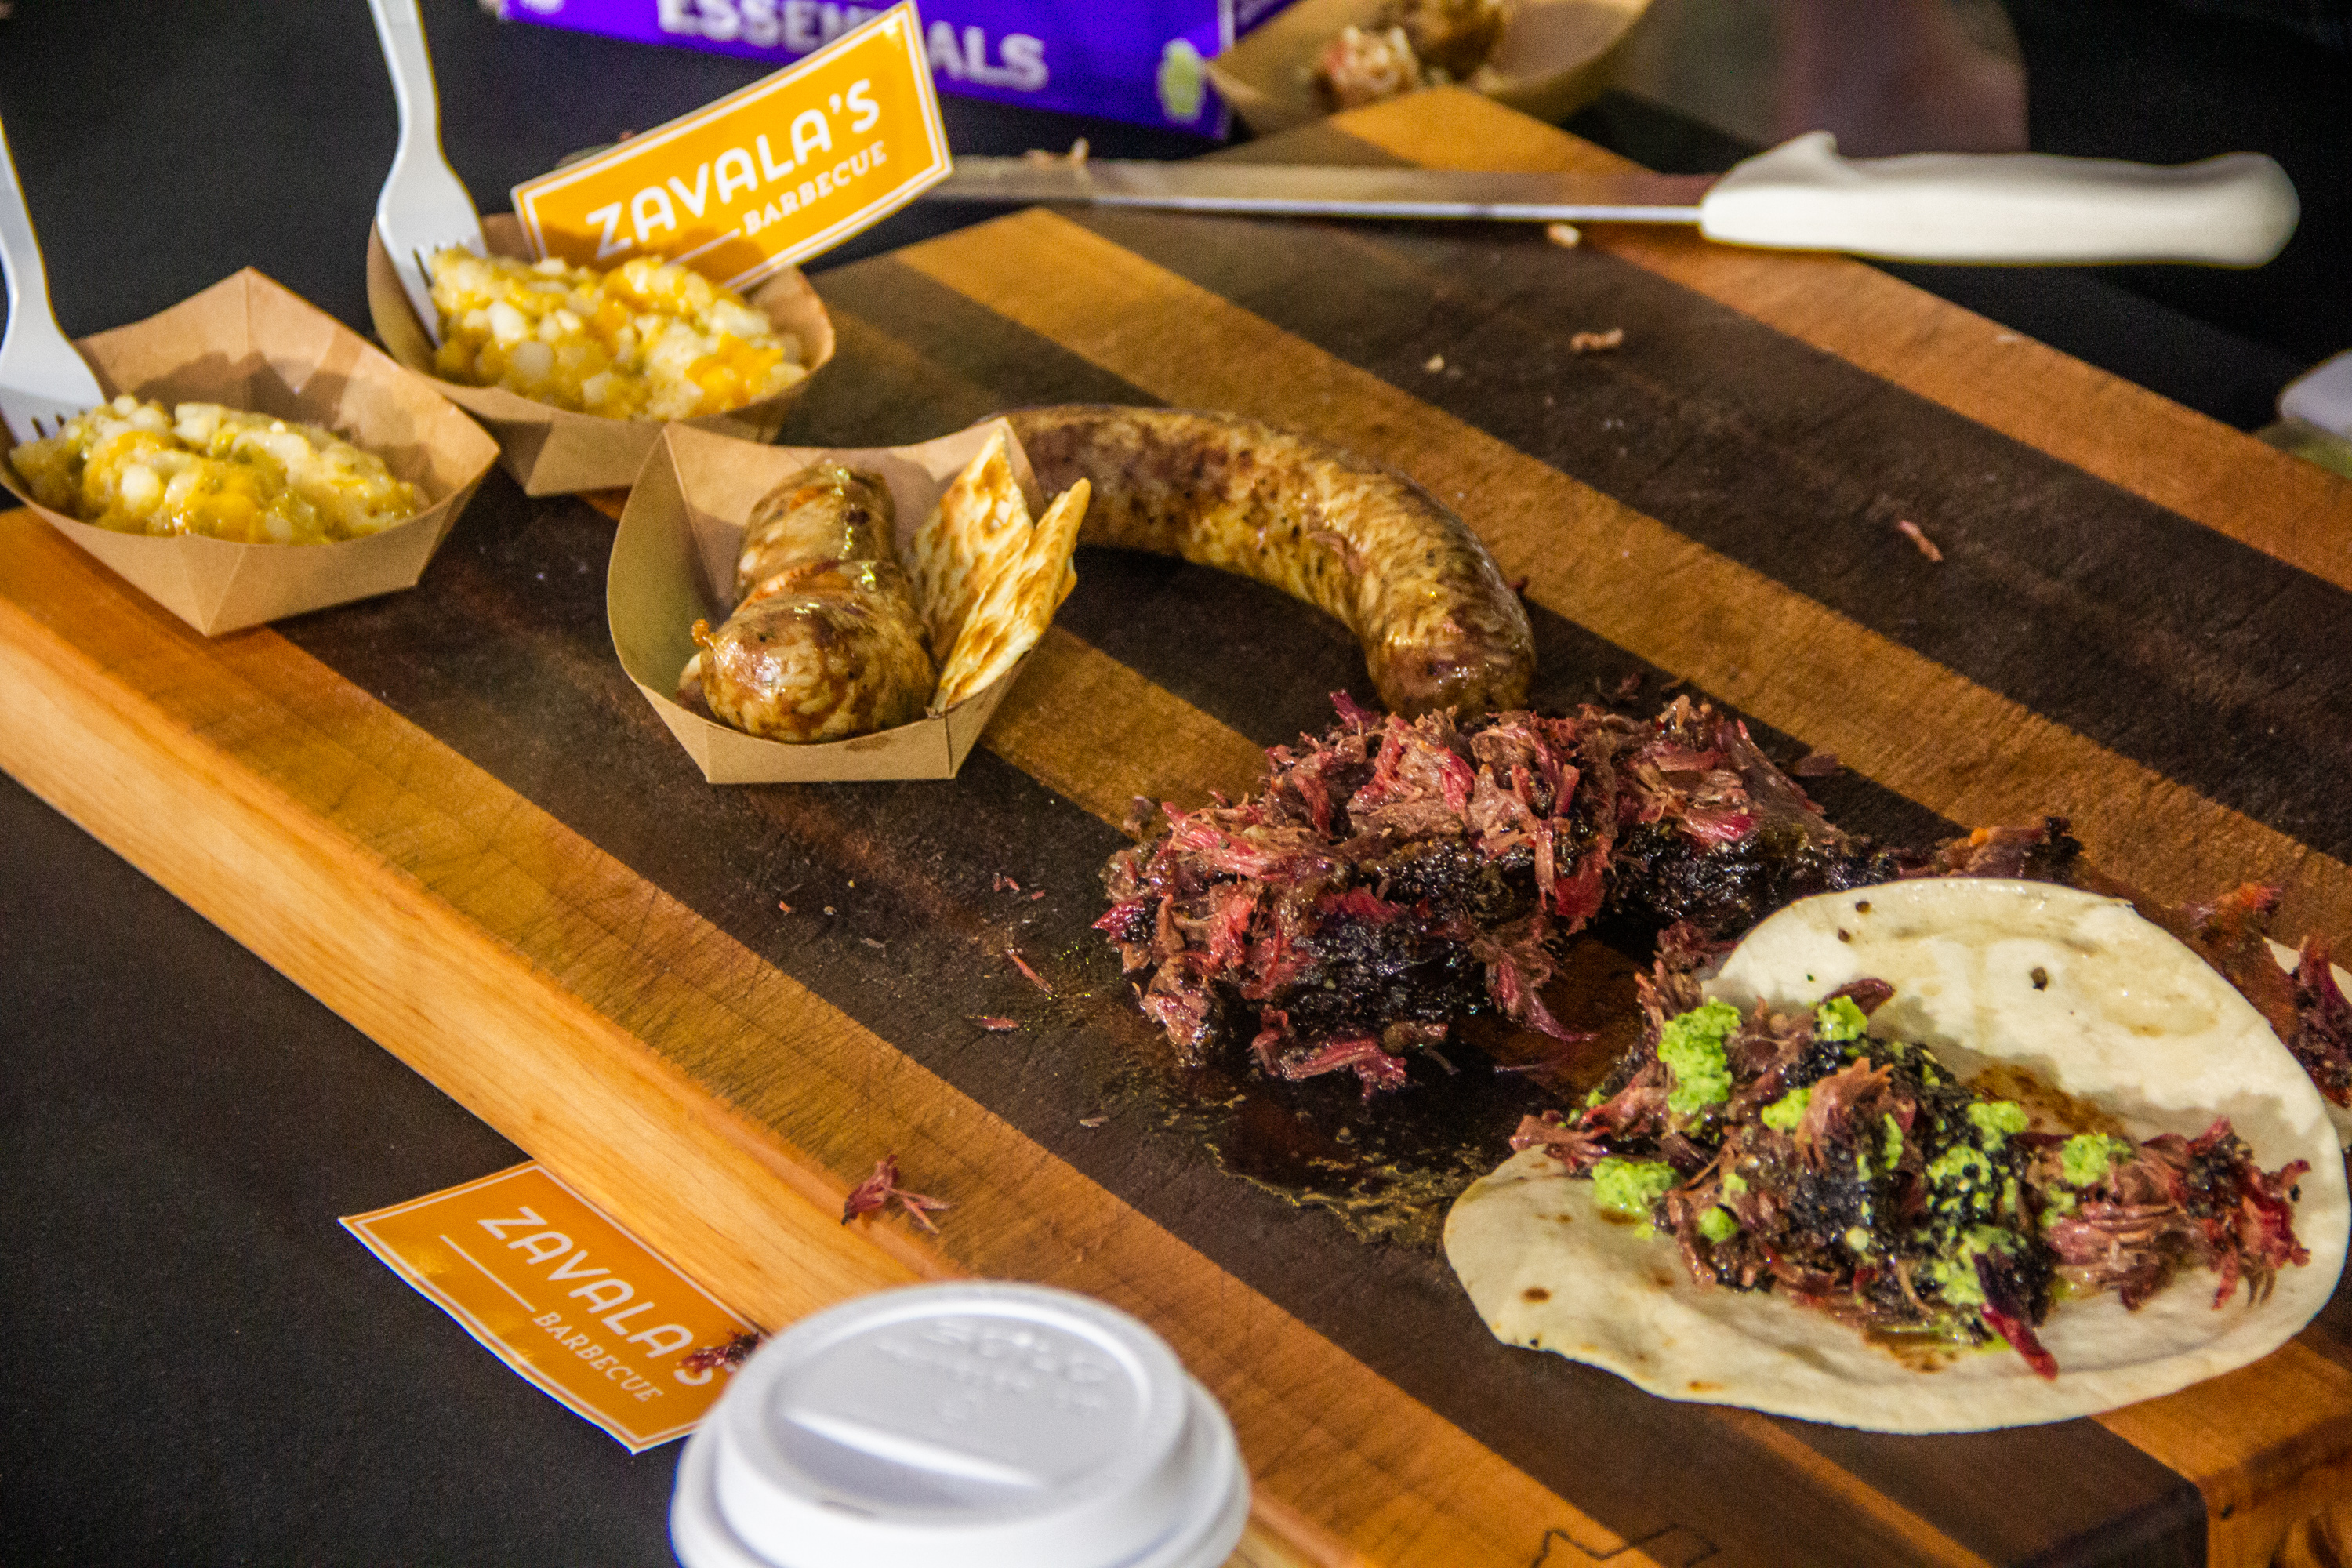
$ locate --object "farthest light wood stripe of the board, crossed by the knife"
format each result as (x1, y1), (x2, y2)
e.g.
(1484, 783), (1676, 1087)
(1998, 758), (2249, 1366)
(1331, 89), (2352, 588)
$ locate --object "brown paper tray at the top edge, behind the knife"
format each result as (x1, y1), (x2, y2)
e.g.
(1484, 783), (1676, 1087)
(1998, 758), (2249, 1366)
(1209, 0), (1649, 136)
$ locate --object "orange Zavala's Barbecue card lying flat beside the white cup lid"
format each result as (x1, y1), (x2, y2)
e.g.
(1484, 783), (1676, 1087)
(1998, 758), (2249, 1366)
(343, 1163), (757, 1453)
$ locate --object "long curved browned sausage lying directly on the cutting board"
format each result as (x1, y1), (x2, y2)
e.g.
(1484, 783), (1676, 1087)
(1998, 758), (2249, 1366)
(1007, 405), (1536, 717)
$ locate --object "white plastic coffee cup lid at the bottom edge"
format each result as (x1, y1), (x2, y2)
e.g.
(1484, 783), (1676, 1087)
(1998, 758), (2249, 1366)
(670, 1283), (1249, 1568)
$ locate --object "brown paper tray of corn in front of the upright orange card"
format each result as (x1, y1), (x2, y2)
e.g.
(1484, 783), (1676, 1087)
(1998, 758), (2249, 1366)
(367, 212), (833, 496)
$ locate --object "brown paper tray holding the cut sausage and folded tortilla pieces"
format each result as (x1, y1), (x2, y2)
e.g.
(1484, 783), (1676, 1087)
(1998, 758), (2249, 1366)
(604, 419), (1044, 783)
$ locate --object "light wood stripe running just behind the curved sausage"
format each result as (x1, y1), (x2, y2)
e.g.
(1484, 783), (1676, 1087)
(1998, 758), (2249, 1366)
(901, 209), (2352, 938)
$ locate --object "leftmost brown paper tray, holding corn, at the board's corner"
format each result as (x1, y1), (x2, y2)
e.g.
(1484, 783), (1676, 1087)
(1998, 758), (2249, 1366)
(0, 268), (499, 637)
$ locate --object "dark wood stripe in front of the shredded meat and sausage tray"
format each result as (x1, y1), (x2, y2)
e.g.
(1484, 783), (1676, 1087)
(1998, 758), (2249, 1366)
(275, 434), (2013, 1563)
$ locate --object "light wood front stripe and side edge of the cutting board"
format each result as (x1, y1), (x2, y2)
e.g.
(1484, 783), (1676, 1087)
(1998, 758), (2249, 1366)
(0, 513), (1712, 1568)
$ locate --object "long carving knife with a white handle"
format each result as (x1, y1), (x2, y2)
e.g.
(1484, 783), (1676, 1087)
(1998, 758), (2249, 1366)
(927, 132), (2300, 266)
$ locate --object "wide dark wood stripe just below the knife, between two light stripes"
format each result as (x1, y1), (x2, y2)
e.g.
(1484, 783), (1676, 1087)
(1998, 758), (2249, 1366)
(1084, 201), (2352, 858)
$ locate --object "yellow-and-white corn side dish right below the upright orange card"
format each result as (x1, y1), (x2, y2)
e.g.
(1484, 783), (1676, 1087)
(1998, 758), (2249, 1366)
(433, 249), (807, 419)
